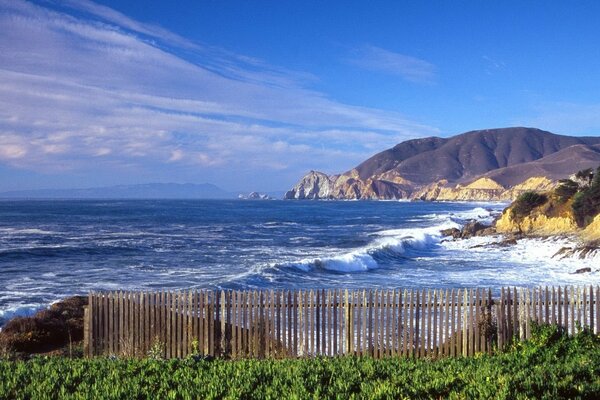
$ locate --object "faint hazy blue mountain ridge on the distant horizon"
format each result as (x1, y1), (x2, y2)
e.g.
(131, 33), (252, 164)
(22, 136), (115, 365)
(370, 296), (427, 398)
(0, 183), (234, 199)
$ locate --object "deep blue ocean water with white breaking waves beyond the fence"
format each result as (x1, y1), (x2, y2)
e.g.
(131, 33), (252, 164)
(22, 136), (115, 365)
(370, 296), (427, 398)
(0, 200), (600, 325)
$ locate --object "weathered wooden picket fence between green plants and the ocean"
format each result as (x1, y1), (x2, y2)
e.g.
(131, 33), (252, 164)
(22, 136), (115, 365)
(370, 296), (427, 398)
(84, 286), (600, 358)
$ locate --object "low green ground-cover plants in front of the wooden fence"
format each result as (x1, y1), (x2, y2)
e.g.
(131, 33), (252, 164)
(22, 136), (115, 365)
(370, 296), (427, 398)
(0, 326), (600, 399)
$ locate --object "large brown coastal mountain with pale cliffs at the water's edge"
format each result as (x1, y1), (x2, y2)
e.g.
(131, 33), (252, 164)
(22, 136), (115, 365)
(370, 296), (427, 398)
(285, 127), (600, 200)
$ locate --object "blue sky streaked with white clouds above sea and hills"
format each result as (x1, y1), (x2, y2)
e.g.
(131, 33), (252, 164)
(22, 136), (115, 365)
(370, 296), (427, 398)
(0, 0), (600, 192)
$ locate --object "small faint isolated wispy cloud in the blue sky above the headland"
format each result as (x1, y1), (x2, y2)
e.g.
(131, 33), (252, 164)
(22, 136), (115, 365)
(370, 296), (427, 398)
(348, 45), (436, 83)
